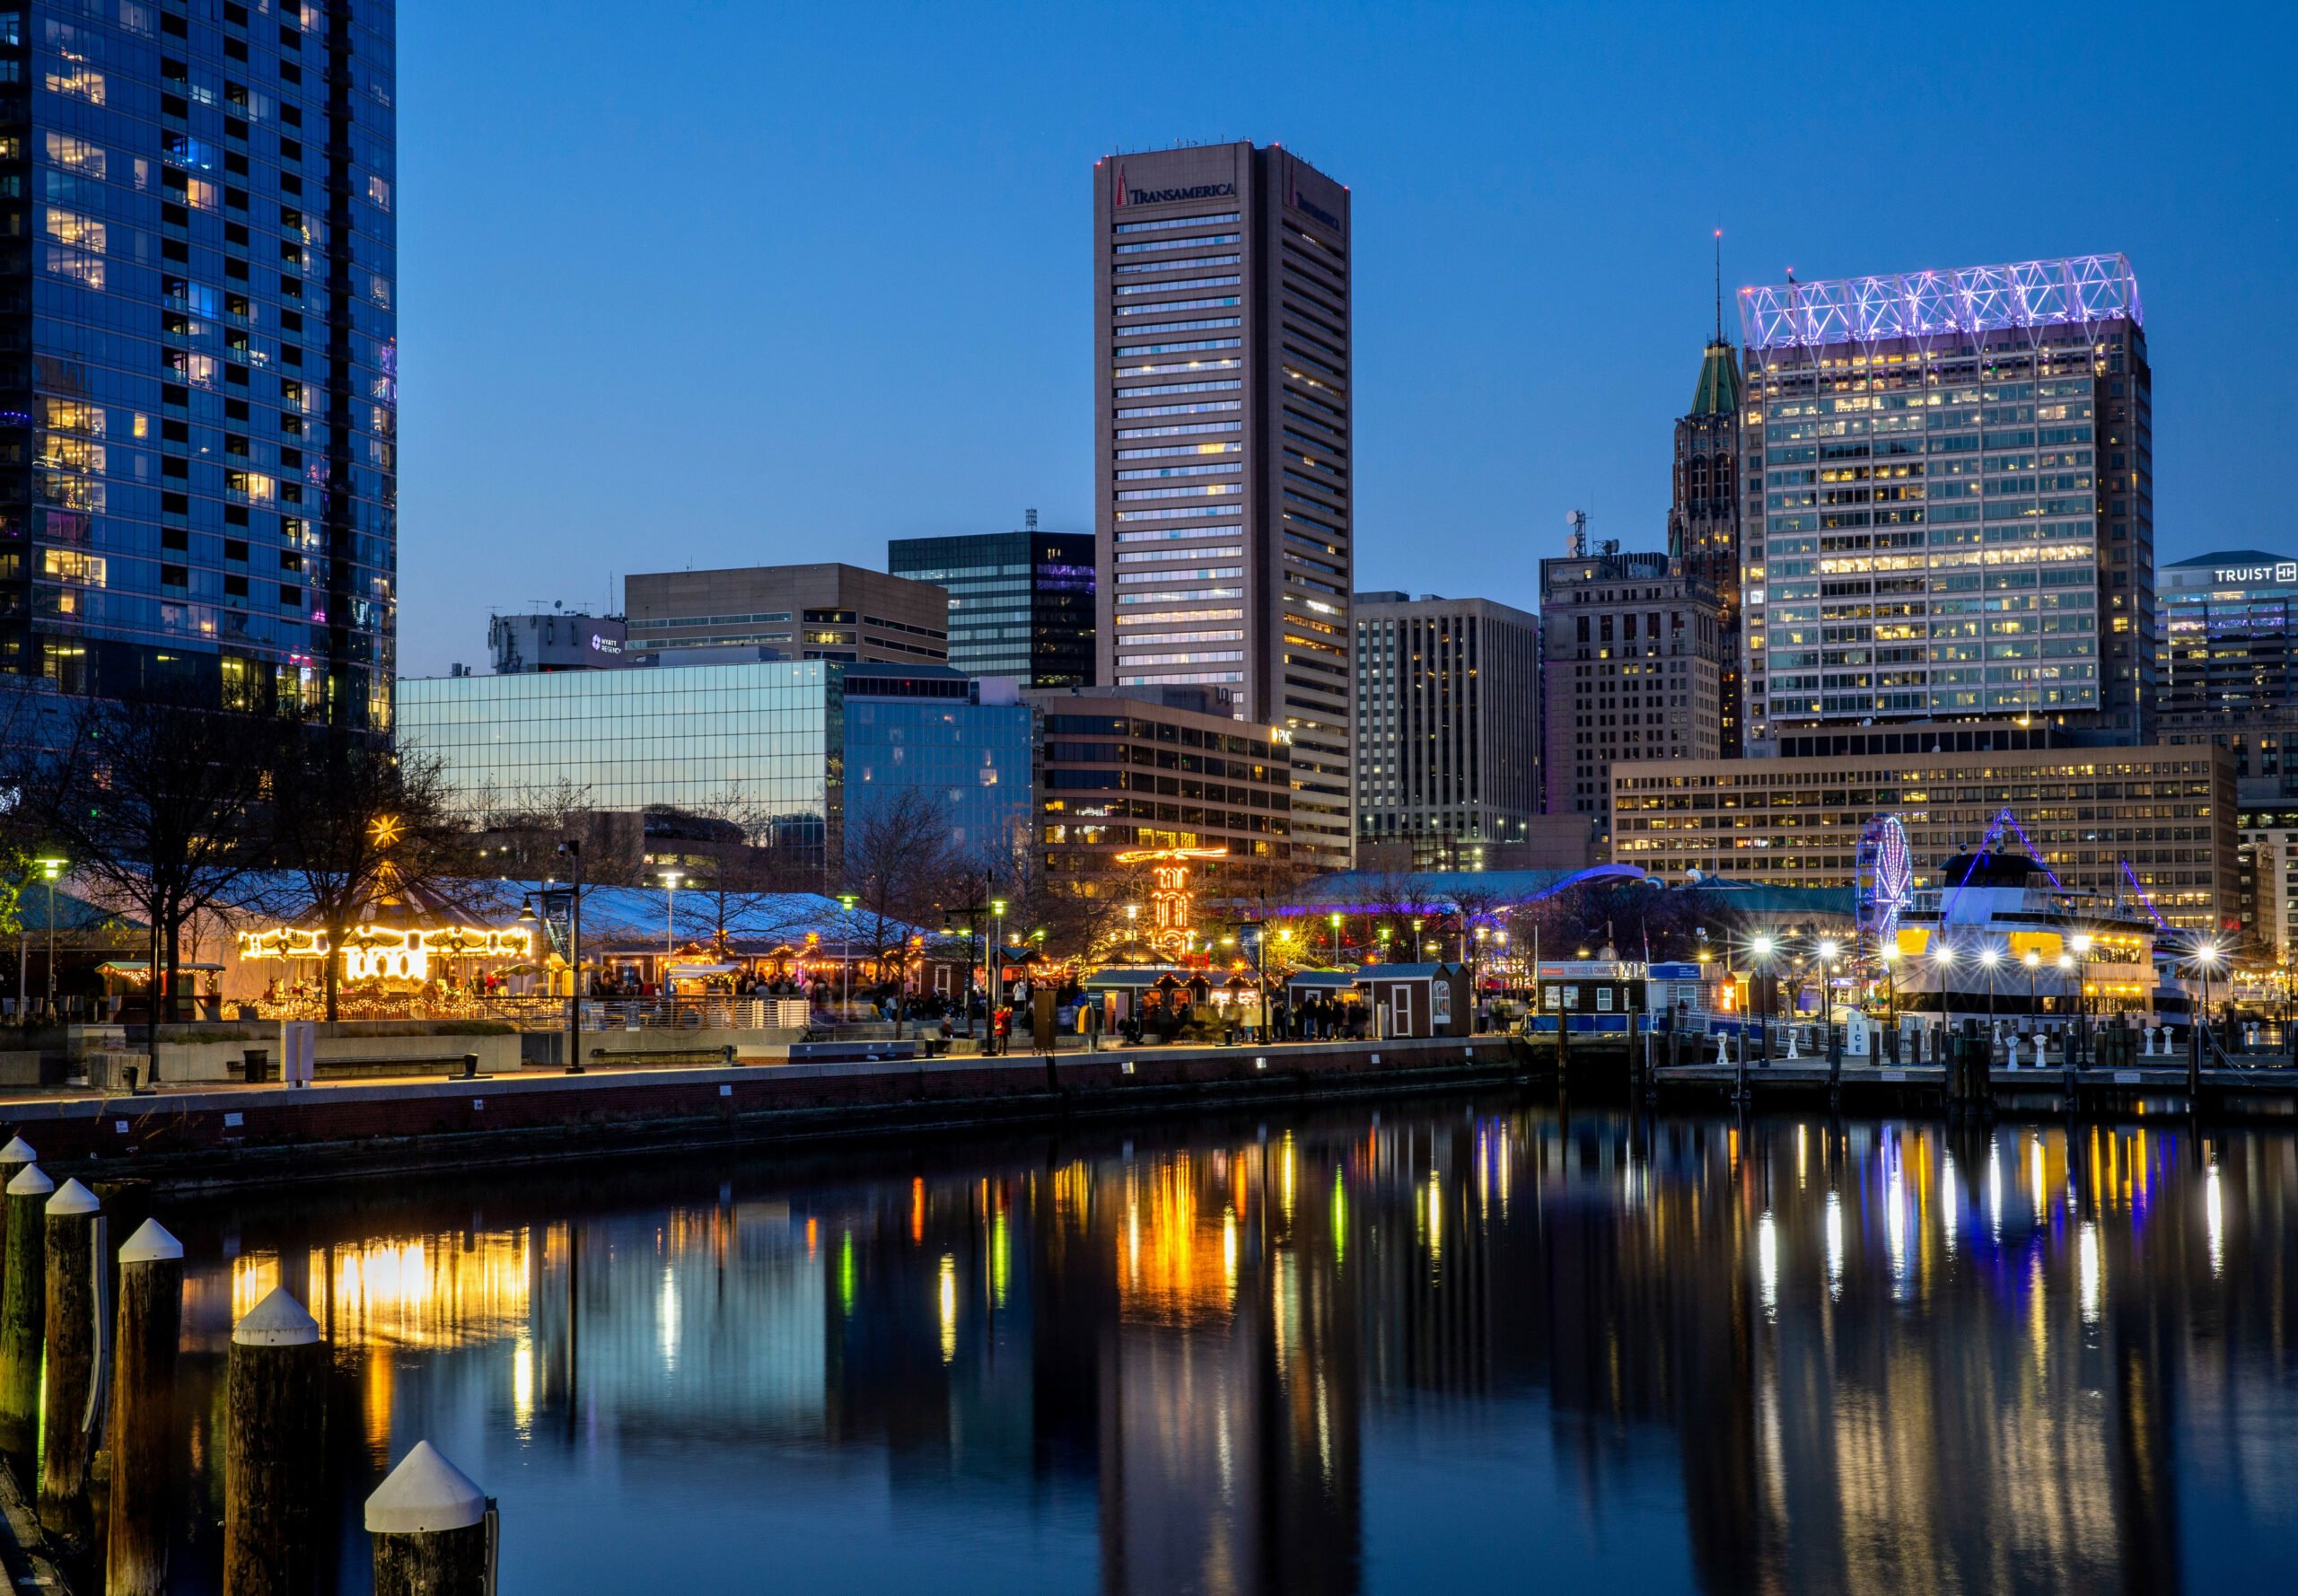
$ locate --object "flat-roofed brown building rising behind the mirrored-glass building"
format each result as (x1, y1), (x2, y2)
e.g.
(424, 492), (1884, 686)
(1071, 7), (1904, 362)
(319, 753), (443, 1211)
(623, 565), (949, 666)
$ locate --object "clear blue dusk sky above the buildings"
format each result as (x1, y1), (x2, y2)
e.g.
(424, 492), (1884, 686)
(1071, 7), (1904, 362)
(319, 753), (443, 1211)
(399, 0), (2298, 675)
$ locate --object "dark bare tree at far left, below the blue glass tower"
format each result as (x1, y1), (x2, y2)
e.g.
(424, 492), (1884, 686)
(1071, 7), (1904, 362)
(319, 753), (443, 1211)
(12, 698), (276, 1068)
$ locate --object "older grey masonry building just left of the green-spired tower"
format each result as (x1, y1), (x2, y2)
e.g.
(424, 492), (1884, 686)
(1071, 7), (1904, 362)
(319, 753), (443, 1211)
(1539, 548), (1724, 836)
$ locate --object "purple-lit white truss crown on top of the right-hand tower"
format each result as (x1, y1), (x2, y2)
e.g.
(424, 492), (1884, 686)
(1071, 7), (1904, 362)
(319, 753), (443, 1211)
(1740, 255), (2146, 349)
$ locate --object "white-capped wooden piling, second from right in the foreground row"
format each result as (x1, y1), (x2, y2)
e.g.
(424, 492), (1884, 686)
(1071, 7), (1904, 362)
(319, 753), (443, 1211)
(223, 1288), (327, 1596)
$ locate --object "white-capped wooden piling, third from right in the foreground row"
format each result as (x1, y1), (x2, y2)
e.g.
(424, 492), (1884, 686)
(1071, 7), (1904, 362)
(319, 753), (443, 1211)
(103, 1219), (184, 1596)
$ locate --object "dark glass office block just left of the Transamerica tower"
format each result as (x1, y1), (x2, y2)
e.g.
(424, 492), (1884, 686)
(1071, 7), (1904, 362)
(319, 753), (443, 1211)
(885, 523), (1094, 687)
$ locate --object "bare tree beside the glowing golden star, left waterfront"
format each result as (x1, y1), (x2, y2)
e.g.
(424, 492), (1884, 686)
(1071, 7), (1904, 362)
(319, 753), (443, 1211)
(271, 725), (469, 1020)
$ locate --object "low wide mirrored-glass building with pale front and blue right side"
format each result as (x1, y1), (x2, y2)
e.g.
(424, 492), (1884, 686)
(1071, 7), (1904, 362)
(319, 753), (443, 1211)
(399, 659), (1037, 886)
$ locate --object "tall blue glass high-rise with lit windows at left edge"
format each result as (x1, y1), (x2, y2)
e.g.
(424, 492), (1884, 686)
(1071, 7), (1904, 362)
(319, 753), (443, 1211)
(0, 0), (398, 732)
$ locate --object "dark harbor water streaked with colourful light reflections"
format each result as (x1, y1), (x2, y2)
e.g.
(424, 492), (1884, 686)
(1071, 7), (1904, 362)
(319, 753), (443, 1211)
(148, 1100), (2298, 1596)
